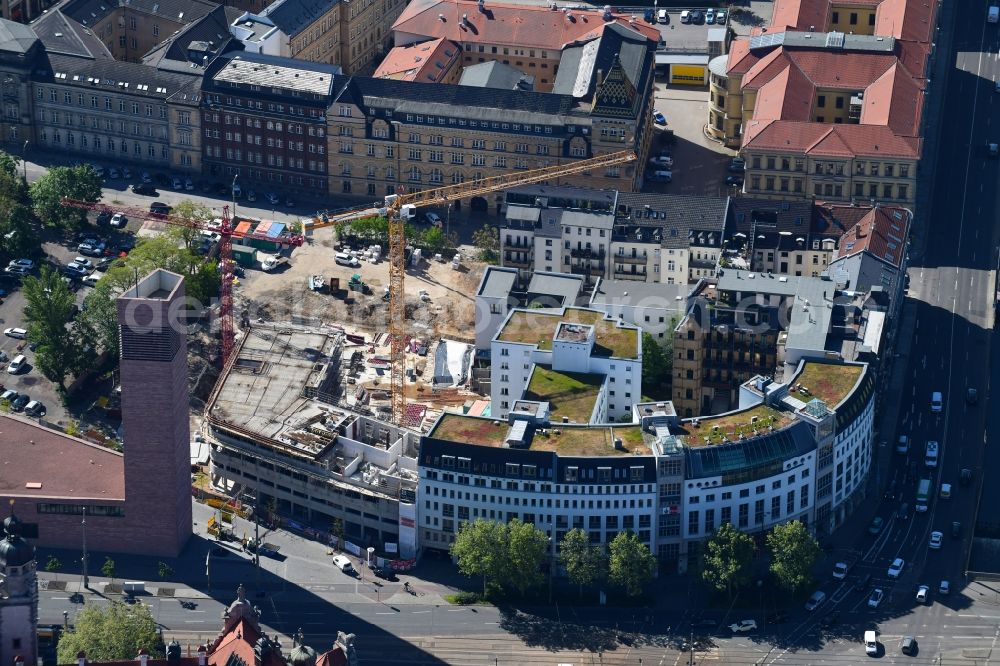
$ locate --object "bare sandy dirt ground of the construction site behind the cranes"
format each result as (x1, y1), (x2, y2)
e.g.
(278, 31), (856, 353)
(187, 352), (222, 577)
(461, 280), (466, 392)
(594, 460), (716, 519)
(234, 227), (485, 341)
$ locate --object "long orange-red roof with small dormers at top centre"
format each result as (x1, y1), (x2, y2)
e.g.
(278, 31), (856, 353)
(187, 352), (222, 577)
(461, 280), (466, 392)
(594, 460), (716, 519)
(392, 0), (660, 50)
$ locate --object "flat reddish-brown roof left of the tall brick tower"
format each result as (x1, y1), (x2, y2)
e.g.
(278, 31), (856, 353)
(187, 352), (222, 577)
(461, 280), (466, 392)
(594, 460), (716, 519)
(0, 414), (125, 501)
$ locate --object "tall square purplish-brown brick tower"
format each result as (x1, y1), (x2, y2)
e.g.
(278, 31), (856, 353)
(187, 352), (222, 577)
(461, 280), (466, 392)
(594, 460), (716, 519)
(118, 269), (191, 557)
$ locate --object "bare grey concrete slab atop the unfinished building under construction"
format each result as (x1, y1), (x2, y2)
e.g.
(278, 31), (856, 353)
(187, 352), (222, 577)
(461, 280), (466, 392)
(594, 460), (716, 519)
(209, 327), (338, 440)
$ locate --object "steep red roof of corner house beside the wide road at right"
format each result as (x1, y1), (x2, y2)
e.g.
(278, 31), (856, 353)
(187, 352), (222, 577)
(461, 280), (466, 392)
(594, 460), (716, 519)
(829, 206), (910, 268)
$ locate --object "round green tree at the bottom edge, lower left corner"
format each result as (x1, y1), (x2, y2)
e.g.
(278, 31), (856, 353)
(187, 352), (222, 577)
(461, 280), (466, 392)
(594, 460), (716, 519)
(57, 602), (162, 664)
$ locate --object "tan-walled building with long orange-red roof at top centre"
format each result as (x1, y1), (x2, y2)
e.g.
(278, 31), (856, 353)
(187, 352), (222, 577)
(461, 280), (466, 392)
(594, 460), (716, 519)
(392, 0), (660, 93)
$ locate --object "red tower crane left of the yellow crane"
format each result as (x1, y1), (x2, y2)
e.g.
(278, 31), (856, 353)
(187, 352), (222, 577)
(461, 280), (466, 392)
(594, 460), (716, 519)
(62, 199), (303, 367)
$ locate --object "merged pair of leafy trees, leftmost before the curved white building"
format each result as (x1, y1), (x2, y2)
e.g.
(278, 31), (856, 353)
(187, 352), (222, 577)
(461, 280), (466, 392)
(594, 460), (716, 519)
(451, 518), (548, 594)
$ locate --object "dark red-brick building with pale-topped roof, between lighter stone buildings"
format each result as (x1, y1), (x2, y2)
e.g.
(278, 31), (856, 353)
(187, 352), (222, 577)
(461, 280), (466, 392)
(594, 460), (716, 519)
(201, 52), (339, 195)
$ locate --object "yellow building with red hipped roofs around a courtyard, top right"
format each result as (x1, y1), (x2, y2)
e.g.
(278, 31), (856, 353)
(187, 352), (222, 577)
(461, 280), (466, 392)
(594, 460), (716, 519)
(708, 0), (937, 209)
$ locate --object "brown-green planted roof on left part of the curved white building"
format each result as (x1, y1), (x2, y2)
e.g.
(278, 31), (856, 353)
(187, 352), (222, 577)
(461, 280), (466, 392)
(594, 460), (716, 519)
(428, 413), (651, 456)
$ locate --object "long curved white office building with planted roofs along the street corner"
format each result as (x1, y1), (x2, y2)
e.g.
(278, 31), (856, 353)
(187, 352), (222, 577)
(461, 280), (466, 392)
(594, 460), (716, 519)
(418, 359), (874, 573)
